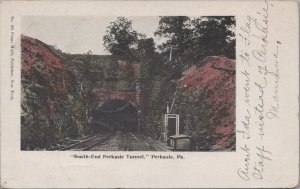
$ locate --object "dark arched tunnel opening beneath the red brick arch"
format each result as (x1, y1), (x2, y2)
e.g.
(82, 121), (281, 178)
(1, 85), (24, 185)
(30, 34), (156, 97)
(92, 100), (138, 133)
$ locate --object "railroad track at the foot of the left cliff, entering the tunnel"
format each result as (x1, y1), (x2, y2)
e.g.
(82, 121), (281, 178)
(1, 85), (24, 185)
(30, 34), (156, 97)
(60, 134), (114, 151)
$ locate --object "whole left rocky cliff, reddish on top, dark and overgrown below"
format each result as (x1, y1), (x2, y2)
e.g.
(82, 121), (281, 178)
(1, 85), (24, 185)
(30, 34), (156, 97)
(21, 36), (88, 149)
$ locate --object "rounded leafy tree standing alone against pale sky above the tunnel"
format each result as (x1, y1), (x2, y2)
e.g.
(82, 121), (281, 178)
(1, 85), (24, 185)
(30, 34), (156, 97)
(103, 17), (139, 59)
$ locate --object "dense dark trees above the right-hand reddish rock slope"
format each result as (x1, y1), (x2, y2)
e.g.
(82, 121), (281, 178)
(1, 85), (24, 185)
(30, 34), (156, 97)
(155, 16), (235, 63)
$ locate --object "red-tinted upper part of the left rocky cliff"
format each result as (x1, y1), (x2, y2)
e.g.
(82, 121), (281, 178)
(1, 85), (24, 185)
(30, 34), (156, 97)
(21, 36), (70, 96)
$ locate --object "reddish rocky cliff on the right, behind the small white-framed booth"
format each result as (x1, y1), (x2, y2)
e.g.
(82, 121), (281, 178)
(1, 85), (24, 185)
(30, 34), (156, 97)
(179, 56), (235, 150)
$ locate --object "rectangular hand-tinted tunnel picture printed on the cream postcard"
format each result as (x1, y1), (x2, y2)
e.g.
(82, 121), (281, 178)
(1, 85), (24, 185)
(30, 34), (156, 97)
(21, 16), (236, 152)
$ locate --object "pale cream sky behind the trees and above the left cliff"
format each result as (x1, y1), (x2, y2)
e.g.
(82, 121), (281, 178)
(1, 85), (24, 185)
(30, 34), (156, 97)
(22, 16), (162, 55)
